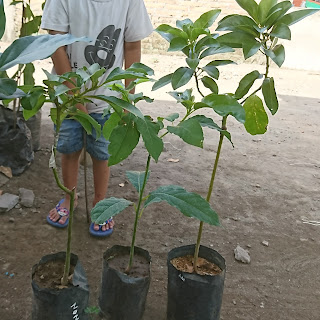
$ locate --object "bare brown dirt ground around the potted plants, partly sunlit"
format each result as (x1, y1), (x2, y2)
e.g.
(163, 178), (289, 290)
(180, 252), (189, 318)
(0, 56), (320, 320)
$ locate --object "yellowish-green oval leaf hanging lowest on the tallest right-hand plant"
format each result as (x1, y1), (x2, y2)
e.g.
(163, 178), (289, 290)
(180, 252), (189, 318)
(243, 95), (268, 135)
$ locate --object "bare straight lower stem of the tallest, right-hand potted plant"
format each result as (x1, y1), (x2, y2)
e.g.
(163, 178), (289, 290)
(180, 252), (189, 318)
(193, 116), (227, 273)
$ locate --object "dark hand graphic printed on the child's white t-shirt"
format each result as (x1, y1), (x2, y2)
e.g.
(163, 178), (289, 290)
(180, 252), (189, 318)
(84, 25), (121, 69)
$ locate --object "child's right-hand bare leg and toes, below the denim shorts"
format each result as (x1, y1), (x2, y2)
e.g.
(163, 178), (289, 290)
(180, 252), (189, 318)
(91, 157), (114, 231)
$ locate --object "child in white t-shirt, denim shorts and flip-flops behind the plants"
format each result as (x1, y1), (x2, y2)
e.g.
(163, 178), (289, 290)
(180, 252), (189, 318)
(41, 0), (153, 236)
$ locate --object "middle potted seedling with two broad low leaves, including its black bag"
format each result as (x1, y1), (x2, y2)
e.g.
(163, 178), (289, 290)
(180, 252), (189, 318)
(91, 66), (219, 320)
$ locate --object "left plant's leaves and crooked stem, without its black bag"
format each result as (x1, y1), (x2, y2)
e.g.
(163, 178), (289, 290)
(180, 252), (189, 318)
(20, 64), (154, 286)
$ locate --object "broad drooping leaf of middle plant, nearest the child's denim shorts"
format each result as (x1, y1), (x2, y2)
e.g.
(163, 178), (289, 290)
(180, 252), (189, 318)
(108, 114), (140, 166)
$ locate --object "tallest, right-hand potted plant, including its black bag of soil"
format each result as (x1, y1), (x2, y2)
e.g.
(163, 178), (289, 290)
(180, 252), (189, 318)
(153, 0), (316, 320)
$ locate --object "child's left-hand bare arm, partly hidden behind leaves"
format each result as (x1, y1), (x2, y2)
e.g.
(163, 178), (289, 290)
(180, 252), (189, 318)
(49, 30), (88, 113)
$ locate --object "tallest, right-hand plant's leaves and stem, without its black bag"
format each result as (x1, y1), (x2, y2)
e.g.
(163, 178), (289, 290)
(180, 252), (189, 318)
(153, 0), (317, 272)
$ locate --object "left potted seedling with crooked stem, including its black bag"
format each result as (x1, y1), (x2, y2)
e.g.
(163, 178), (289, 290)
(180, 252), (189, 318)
(21, 64), (152, 320)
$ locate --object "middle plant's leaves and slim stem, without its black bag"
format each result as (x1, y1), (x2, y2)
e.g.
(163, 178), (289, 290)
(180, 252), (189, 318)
(91, 66), (219, 275)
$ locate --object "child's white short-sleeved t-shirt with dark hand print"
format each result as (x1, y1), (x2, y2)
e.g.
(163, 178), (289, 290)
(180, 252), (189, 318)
(41, 0), (153, 113)
